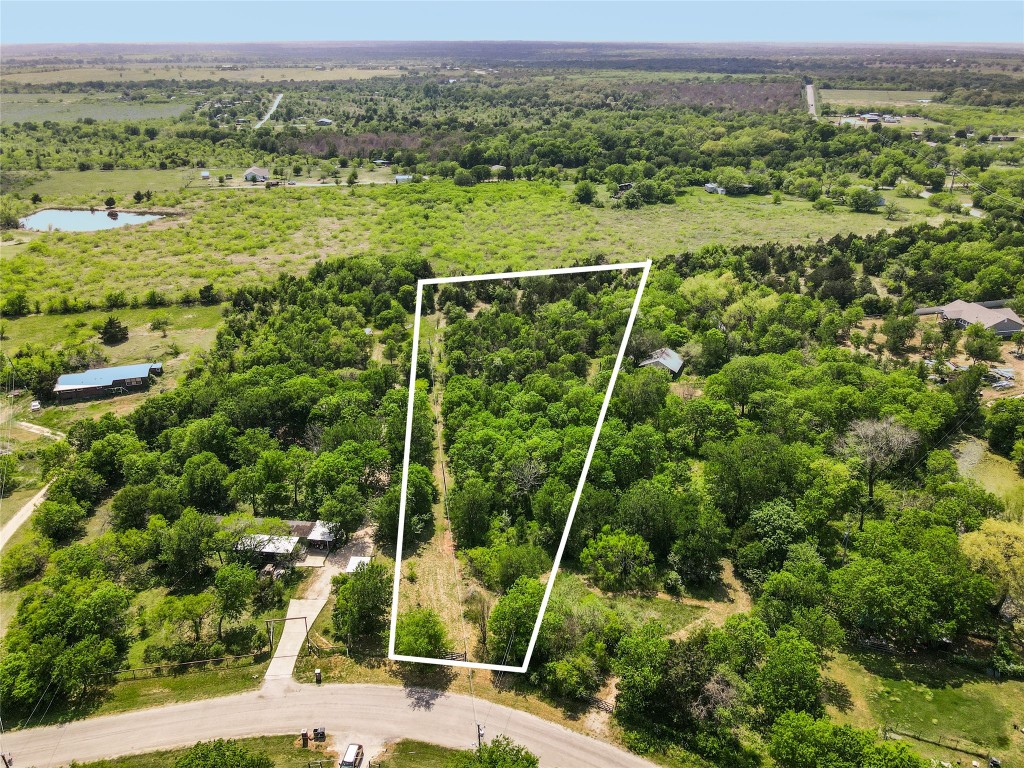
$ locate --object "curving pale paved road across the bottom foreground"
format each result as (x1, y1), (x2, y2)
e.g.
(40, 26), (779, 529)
(0, 681), (651, 768)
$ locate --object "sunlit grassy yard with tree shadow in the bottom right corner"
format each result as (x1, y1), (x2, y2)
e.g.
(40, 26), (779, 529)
(825, 651), (1024, 768)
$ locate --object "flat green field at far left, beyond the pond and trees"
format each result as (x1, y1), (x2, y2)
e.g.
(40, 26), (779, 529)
(0, 93), (191, 123)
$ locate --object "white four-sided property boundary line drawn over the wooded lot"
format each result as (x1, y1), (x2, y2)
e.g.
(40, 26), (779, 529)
(387, 261), (651, 672)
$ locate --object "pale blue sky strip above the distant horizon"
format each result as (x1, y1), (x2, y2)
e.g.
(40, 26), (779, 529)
(0, 0), (1024, 45)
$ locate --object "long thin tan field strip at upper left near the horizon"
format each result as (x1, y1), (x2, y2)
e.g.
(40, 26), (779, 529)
(4, 65), (403, 85)
